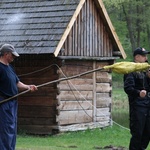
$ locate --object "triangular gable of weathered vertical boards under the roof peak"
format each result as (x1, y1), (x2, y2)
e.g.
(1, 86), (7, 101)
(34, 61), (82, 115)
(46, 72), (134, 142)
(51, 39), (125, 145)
(59, 0), (123, 59)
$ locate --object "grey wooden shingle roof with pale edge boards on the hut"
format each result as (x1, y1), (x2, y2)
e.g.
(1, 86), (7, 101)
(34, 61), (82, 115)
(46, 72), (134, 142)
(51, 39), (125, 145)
(0, 0), (126, 58)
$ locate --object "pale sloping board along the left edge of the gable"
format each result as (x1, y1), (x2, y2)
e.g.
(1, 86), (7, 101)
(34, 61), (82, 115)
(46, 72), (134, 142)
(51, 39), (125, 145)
(54, 0), (85, 57)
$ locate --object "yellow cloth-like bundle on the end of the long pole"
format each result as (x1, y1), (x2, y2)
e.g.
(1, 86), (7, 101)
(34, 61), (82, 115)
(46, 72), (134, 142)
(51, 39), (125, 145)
(103, 62), (150, 74)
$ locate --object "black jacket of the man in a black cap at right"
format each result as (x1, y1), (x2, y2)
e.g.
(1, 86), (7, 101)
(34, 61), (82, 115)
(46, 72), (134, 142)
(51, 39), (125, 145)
(124, 72), (150, 107)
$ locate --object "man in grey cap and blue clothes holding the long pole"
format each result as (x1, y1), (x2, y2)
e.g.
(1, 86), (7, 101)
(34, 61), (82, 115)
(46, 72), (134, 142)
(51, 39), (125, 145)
(0, 44), (37, 150)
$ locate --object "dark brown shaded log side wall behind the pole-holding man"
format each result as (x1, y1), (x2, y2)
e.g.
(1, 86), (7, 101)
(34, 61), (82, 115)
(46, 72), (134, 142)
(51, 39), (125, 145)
(14, 55), (58, 134)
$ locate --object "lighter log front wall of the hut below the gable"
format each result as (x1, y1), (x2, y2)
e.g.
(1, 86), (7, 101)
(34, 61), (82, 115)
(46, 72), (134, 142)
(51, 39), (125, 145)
(57, 60), (112, 131)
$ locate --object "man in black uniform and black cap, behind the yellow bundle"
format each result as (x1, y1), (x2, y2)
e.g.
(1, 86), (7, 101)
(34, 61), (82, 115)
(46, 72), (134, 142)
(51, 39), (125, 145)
(124, 47), (150, 150)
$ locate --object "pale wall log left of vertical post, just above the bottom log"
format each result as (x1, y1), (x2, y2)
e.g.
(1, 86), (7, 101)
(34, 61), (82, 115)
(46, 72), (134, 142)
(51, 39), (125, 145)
(57, 110), (92, 125)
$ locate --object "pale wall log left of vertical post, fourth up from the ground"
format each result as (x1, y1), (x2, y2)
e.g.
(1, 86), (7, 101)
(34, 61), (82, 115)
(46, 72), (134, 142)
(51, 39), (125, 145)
(57, 91), (93, 101)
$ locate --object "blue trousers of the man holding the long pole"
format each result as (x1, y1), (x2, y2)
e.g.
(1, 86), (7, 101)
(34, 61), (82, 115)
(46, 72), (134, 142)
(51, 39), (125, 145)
(0, 100), (18, 150)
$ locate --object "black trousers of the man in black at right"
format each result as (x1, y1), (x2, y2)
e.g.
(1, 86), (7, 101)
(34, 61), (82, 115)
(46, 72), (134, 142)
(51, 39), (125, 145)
(129, 106), (150, 150)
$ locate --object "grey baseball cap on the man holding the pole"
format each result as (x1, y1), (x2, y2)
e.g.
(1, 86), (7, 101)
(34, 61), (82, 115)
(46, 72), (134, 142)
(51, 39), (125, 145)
(0, 44), (19, 57)
